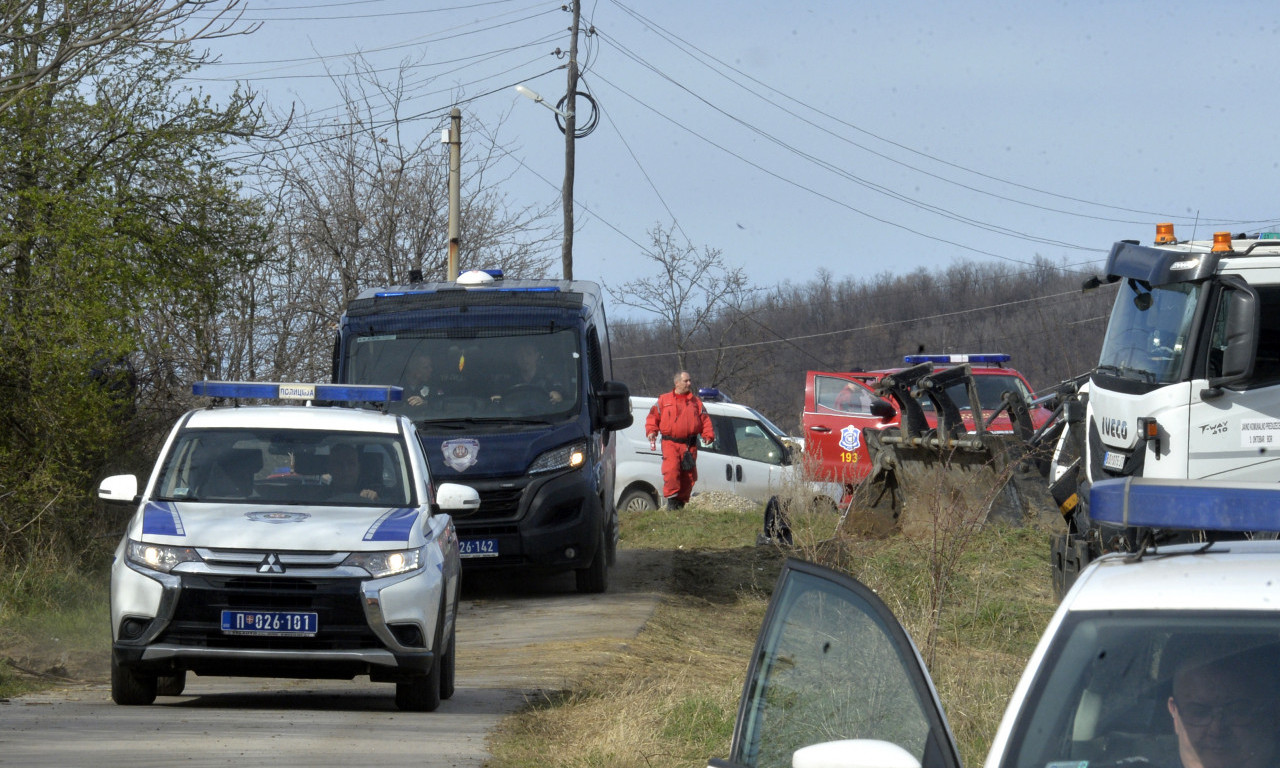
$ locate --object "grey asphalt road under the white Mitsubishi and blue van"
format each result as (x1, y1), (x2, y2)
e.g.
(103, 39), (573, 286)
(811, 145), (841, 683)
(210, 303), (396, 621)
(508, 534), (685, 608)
(0, 550), (671, 768)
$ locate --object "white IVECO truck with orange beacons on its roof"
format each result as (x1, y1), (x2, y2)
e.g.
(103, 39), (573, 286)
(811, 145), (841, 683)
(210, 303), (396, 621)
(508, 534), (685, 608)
(1052, 224), (1280, 590)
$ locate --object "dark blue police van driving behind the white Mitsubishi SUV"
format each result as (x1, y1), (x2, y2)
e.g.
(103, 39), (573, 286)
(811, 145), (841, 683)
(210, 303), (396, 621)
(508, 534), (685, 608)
(333, 270), (631, 593)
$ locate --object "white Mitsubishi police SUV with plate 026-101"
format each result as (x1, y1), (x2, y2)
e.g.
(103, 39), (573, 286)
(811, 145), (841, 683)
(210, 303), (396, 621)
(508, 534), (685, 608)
(99, 381), (479, 710)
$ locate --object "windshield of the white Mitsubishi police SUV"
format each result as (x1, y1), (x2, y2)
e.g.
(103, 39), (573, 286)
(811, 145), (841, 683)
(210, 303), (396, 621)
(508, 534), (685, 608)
(156, 429), (416, 507)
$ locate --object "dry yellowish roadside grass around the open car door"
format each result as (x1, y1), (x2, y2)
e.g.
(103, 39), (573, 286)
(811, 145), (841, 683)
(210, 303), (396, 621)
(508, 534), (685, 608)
(492, 486), (1055, 768)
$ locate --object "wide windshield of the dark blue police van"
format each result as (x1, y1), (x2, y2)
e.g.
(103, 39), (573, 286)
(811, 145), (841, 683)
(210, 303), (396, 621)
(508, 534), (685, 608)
(347, 329), (581, 421)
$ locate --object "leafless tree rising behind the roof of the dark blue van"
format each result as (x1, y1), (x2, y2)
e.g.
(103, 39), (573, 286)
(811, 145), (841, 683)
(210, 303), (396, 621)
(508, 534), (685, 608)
(243, 58), (558, 380)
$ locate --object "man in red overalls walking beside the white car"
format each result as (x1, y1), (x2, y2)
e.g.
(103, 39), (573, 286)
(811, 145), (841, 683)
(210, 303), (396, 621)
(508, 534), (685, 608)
(645, 371), (716, 509)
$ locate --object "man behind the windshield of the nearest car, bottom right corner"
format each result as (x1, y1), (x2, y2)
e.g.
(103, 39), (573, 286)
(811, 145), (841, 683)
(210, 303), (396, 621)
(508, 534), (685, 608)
(1167, 652), (1280, 768)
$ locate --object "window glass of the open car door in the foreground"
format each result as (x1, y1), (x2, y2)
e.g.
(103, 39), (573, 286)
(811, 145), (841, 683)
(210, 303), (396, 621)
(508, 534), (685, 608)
(733, 563), (931, 768)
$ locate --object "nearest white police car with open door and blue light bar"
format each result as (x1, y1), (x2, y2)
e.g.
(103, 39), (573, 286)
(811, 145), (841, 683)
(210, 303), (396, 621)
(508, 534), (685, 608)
(709, 479), (1280, 768)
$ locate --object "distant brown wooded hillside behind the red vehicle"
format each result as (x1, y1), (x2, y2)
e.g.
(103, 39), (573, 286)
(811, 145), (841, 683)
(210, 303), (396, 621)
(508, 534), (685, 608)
(613, 250), (1115, 435)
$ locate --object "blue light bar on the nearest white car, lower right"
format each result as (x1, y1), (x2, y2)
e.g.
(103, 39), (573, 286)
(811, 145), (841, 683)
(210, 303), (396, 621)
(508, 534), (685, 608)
(1089, 477), (1280, 531)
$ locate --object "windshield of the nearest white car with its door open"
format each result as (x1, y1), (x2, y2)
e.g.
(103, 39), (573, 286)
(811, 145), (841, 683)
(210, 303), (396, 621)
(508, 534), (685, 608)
(1001, 611), (1280, 768)
